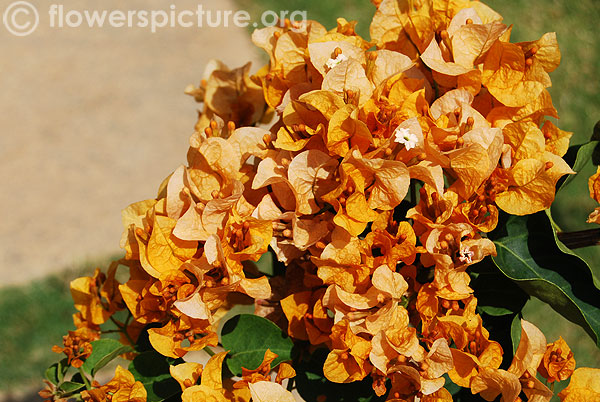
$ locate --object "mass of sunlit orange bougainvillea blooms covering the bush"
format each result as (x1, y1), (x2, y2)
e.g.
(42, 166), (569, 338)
(50, 0), (600, 402)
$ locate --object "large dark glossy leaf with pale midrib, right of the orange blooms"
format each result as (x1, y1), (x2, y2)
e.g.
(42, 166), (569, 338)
(490, 211), (600, 346)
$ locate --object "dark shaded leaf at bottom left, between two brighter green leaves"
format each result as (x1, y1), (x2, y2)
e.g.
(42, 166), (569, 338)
(129, 351), (183, 402)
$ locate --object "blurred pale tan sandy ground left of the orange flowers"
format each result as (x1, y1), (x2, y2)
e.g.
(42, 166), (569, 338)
(0, 0), (259, 286)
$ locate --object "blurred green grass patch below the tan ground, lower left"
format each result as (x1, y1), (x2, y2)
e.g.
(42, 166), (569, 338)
(0, 259), (117, 391)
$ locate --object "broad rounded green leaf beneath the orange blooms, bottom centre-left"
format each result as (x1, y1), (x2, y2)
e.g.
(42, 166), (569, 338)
(221, 314), (294, 375)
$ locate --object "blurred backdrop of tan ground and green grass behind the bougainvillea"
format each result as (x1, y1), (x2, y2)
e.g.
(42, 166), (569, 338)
(0, 0), (600, 401)
